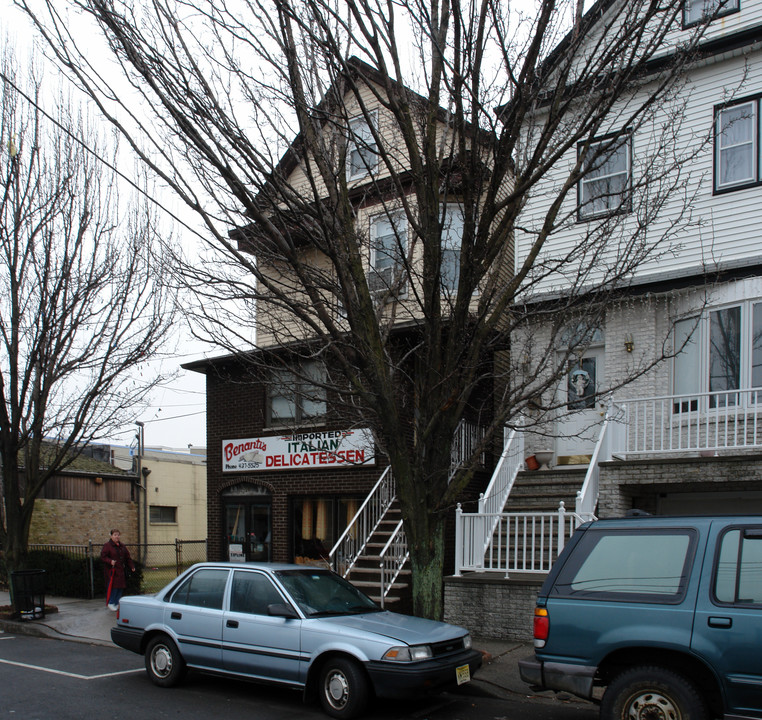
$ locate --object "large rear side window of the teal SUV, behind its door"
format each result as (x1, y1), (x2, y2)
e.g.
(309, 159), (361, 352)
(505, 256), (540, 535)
(554, 529), (696, 602)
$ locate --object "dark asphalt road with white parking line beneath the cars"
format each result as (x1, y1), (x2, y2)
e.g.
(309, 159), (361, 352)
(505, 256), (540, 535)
(0, 634), (597, 720)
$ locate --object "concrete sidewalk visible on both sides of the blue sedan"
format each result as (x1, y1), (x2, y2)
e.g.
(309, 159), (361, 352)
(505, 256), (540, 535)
(0, 591), (572, 702)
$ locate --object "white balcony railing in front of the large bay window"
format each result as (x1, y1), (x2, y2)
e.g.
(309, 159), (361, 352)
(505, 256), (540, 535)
(611, 389), (762, 455)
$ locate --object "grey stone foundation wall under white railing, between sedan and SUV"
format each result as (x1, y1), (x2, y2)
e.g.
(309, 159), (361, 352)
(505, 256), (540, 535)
(444, 573), (545, 642)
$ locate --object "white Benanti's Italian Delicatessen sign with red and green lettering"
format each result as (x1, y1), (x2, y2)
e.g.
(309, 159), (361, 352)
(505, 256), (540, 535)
(222, 429), (376, 472)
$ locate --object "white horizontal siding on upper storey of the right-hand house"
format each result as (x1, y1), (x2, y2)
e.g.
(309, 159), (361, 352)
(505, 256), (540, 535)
(516, 33), (762, 292)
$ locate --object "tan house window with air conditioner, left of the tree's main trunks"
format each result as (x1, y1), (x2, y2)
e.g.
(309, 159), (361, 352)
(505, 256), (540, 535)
(368, 213), (407, 295)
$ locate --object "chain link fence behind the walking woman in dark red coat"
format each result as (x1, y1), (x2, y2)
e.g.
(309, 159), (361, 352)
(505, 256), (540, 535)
(21, 539), (207, 598)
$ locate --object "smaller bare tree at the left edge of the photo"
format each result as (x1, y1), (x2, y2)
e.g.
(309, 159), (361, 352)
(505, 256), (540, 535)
(0, 43), (172, 584)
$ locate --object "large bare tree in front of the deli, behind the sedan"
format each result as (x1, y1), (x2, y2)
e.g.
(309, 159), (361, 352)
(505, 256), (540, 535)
(19, 0), (720, 617)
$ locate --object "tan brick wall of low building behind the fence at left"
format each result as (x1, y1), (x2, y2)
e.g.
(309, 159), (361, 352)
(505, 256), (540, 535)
(29, 499), (138, 545)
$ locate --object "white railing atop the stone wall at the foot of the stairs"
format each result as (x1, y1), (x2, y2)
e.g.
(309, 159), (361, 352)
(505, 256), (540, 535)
(455, 502), (584, 577)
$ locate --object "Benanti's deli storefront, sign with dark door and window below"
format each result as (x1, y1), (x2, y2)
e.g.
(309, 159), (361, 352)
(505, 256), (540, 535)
(219, 429), (379, 565)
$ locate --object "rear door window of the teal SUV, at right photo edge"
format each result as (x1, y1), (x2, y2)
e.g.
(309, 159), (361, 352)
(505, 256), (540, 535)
(714, 528), (762, 605)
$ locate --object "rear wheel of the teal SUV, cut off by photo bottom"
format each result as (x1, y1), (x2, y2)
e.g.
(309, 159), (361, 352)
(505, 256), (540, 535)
(601, 666), (709, 720)
